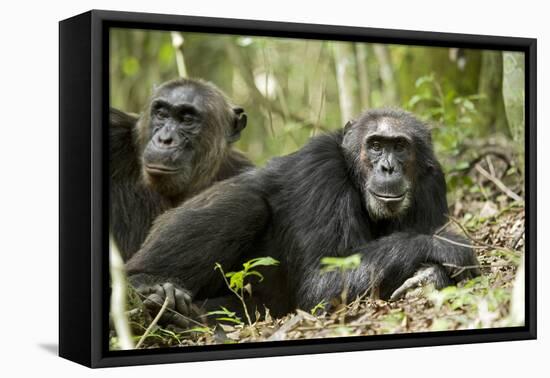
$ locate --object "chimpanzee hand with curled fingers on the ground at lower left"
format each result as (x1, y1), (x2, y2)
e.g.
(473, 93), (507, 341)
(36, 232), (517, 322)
(136, 282), (198, 328)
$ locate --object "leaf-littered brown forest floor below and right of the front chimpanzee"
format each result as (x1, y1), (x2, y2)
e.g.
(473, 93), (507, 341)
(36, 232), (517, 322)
(111, 156), (525, 348)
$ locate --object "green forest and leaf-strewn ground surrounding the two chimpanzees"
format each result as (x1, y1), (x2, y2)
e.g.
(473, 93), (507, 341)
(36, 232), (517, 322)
(110, 29), (525, 347)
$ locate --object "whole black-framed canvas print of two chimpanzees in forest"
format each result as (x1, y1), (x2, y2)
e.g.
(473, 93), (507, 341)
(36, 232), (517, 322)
(59, 10), (536, 367)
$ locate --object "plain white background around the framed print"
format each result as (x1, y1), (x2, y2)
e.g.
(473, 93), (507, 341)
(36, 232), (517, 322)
(0, 0), (550, 378)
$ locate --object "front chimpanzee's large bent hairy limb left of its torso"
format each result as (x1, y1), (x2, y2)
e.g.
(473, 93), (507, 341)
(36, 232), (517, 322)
(126, 175), (270, 314)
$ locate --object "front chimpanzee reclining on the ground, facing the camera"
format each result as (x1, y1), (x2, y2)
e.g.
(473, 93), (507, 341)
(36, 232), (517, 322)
(126, 110), (479, 321)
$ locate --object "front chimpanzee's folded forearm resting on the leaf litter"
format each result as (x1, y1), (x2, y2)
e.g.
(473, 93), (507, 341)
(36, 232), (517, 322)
(297, 232), (479, 310)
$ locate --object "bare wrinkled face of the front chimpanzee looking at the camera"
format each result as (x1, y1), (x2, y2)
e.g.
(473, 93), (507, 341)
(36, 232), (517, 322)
(361, 119), (414, 219)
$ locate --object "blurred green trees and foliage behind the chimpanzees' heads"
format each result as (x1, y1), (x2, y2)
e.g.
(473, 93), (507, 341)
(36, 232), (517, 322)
(110, 29), (524, 179)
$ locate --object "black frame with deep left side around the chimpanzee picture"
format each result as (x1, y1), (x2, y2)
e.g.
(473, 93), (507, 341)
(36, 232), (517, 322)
(59, 10), (537, 367)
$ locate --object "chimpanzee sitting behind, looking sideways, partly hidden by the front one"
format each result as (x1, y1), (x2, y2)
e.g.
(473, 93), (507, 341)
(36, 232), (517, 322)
(110, 79), (252, 259)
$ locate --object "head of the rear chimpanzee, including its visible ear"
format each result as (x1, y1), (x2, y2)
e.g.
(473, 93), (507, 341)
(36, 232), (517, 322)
(140, 80), (246, 195)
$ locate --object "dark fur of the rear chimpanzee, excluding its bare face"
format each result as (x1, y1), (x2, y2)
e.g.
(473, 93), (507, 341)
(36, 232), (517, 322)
(109, 79), (253, 260)
